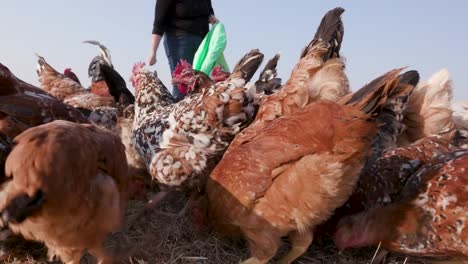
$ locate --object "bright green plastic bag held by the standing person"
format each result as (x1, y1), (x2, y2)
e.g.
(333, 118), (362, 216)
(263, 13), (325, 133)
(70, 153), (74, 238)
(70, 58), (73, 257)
(192, 23), (230, 76)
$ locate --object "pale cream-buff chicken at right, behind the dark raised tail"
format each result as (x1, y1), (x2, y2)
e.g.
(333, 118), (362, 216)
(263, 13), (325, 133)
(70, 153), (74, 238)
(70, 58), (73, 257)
(398, 69), (455, 146)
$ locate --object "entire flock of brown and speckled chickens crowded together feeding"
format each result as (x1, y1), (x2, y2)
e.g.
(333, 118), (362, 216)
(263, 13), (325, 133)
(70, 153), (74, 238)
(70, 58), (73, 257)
(0, 8), (468, 264)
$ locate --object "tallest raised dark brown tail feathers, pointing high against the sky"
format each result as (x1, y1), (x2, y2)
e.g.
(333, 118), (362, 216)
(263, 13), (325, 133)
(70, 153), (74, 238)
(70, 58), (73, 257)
(301, 7), (345, 61)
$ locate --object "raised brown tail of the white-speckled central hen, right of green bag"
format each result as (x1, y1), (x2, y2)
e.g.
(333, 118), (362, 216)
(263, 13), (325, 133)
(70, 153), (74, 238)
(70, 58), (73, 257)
(229, 49), (263, 83)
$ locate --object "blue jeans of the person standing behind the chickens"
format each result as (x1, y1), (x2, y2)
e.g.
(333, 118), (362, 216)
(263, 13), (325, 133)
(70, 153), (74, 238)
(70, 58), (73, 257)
(164, 34), (203, 102)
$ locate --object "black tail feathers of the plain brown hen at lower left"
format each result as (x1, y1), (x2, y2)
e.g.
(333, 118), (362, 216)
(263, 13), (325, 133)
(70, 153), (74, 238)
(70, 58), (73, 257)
(1, 190), (46, 223)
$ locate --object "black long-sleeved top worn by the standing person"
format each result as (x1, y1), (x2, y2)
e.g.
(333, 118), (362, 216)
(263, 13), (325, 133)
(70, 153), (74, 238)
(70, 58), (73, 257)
(153, 0), (214, 37)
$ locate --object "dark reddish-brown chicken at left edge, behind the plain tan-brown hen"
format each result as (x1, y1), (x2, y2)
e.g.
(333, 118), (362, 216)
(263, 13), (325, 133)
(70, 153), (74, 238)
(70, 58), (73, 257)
(0, 64), (88, 182)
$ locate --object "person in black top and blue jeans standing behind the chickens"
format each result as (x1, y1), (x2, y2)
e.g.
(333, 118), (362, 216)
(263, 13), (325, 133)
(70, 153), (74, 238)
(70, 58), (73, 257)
(147, 0), (219, 101)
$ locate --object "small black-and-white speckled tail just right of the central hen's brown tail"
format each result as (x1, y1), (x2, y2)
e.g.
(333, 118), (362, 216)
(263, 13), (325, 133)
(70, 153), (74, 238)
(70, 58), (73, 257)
(255, 54), (281, 95)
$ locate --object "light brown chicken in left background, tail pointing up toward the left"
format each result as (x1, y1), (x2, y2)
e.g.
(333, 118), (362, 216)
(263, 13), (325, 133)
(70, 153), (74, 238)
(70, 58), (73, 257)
(37, 55), (115, 110)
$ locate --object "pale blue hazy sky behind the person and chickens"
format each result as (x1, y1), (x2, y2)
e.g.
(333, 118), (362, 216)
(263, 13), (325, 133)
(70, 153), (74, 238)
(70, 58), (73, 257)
(0, 0), (468, 100)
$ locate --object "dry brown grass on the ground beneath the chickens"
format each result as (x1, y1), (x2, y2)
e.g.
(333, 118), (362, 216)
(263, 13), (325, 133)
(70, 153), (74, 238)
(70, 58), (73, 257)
(0, 192), (432, 264)
